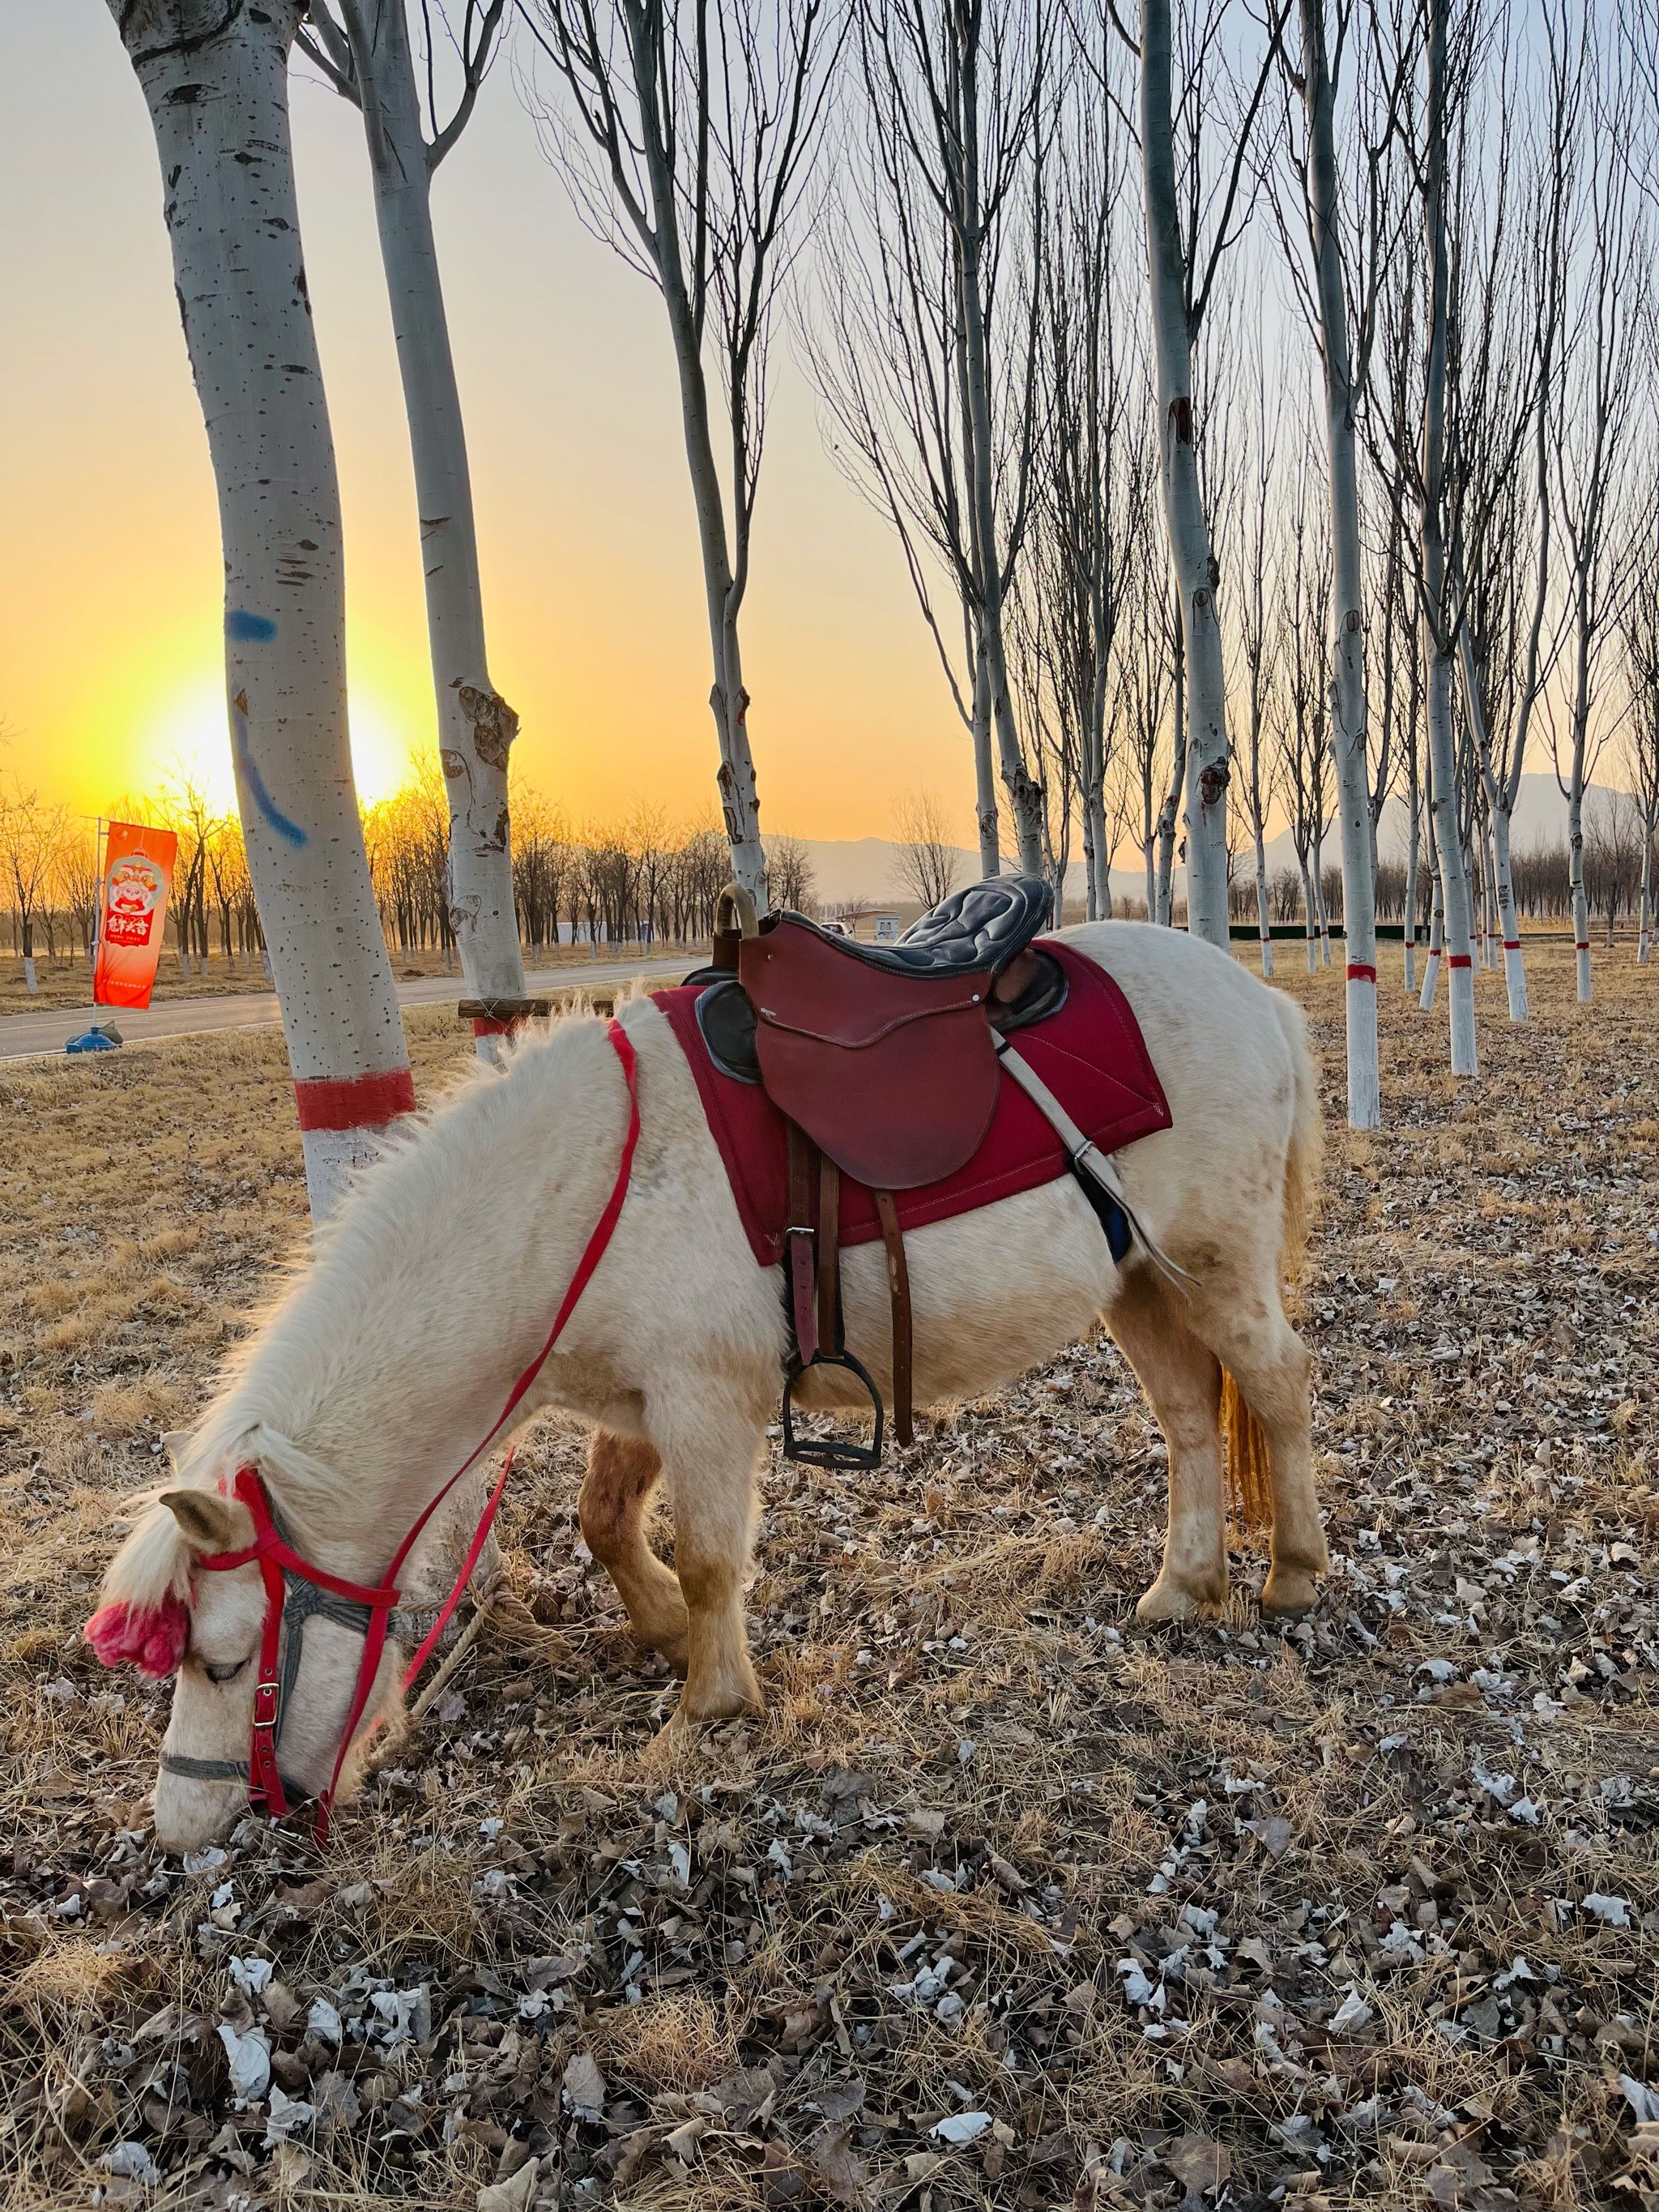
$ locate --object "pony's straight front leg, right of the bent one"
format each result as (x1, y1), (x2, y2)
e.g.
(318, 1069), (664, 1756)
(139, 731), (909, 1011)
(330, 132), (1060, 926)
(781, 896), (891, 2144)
(646, 1378), (766, 1721)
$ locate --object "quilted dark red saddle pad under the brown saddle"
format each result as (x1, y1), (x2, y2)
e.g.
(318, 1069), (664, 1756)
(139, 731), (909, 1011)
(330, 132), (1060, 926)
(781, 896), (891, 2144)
(650, 938), (1172, 1267)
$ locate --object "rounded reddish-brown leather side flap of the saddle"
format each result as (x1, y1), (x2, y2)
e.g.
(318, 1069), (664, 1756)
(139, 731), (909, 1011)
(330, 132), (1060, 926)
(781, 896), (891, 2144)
(739, 918), (1002, 1190)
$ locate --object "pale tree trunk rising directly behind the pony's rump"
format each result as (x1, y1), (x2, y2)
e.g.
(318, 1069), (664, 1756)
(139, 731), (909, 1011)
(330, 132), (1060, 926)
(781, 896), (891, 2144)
(1141, 0), (1230, 951)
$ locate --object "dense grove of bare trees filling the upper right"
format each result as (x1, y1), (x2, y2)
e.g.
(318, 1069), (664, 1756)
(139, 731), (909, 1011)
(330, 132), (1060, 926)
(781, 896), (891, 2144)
(801, 0), (1659, 1126)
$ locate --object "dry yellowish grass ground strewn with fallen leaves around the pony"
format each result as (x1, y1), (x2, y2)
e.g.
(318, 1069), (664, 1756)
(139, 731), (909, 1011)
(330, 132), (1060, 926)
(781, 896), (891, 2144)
(0, 951), (1659, 2212)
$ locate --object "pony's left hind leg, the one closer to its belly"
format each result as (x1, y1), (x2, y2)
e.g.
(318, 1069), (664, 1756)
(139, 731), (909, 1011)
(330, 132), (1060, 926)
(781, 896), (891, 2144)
(1106, 1267), (1228, 1621)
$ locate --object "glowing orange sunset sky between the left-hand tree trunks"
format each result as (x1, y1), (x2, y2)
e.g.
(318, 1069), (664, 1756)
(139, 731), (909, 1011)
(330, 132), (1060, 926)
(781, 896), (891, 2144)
(0, 0), (973, 843)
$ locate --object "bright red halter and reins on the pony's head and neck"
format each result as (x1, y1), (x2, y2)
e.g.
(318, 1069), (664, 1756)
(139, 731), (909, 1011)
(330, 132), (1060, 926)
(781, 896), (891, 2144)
(179, 1022), (639, 1843)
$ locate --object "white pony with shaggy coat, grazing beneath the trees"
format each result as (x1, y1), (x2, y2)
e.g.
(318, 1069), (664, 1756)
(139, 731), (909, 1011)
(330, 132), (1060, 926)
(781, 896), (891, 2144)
(100, 922), (1327, 1849)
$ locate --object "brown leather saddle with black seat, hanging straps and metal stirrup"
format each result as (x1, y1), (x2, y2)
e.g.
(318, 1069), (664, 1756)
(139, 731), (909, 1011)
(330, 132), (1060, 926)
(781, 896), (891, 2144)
(697, 876), (1064, 1467)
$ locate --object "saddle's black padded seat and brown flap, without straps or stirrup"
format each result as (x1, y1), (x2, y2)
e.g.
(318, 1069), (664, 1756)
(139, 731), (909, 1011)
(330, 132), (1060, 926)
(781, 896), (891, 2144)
(739, 876), (1053, 1190)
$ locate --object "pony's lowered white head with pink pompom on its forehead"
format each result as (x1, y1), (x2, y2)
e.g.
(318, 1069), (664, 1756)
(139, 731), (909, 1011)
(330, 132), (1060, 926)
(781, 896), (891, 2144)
(86, 1438), (399, 1851)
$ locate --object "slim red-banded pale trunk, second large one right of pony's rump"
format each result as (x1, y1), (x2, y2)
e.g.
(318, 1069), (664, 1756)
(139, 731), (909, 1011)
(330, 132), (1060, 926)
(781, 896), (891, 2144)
(1422, 0), (1478, 1075)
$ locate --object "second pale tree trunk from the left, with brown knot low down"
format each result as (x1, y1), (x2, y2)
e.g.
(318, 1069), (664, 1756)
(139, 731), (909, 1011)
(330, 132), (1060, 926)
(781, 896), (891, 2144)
(343, 0), (524, 1057)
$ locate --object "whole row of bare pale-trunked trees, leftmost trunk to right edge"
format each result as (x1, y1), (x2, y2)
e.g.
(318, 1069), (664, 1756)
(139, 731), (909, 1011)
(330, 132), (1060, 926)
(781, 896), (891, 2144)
(111, 0), (1659, 1203)
